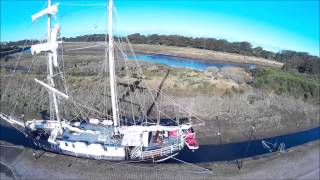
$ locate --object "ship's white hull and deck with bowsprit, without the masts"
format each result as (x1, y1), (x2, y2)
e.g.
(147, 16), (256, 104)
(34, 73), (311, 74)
(0, 114), (197, 162)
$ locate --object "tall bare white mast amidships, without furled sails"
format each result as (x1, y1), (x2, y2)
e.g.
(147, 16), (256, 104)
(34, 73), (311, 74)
(108, 0), (119, 127)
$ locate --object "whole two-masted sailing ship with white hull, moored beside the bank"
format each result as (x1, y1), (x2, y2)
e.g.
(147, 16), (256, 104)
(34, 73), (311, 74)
(0, 0), (199, 162)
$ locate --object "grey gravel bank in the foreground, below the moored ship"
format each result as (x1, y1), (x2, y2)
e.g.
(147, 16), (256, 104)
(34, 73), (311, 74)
(1, 140), (320, 180)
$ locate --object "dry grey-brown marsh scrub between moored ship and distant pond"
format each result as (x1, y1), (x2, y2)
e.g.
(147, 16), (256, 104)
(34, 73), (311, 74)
(0, 45), (319, 143)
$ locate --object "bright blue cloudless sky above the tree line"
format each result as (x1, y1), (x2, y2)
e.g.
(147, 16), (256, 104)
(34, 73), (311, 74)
(0, 0), (320, 56)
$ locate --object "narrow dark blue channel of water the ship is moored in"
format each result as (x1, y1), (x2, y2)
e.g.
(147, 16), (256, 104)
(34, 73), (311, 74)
(0, 122), (320, 163)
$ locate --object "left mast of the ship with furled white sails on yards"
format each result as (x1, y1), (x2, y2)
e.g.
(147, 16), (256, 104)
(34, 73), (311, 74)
(31, 0), (63, 134)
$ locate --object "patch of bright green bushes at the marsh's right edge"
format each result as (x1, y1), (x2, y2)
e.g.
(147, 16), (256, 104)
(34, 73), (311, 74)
(254, 68), (320, 101)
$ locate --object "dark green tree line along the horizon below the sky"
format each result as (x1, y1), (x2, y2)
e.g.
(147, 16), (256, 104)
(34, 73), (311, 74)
(1, 33), (320, 74)
